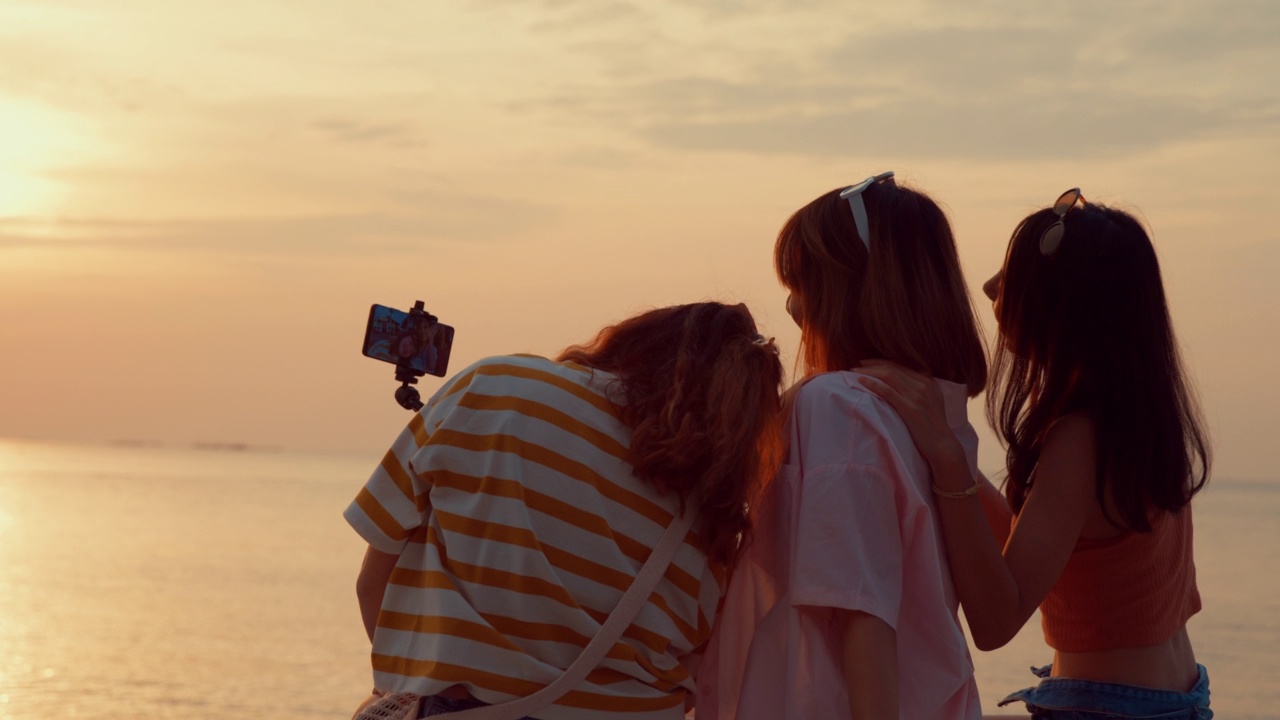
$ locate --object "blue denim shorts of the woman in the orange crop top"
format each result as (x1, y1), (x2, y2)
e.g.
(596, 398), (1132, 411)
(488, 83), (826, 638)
(1000, 665), (1213, 720)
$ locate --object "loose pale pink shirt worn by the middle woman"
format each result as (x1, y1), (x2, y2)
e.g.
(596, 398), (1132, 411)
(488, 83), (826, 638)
(696, 373), (982, 720)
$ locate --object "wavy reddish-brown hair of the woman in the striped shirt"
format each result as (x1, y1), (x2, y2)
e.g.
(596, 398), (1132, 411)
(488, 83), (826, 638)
(557, 302), (782, 562)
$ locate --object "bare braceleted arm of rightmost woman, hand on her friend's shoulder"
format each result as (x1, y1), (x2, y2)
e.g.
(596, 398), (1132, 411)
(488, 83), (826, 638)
(863, 364), (1097, 650)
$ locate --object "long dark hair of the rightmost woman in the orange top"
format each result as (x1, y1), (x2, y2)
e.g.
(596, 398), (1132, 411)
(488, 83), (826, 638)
(987, 204), (1210, 532)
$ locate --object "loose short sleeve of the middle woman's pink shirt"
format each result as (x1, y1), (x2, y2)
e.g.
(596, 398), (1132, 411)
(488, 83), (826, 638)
(790, 465), (904, 629)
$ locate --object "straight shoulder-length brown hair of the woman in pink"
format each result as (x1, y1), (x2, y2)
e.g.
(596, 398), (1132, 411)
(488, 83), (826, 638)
(773, 182), (987, 397)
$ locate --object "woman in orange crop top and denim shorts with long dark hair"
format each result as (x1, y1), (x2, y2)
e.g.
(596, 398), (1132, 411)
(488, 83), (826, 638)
(864, 190), (1212, 717)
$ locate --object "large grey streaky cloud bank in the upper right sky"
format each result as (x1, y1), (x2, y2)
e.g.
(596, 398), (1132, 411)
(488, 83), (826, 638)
(518, 0), (1280, 160)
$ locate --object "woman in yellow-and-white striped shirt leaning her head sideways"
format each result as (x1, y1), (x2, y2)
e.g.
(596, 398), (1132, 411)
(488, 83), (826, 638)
(346, 302), (782, 720)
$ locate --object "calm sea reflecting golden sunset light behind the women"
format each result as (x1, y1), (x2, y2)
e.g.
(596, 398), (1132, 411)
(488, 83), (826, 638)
(0, 442), (1280, 720)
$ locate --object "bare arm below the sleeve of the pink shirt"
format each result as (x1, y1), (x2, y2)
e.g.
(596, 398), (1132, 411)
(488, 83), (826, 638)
(838, 610), (899, 720)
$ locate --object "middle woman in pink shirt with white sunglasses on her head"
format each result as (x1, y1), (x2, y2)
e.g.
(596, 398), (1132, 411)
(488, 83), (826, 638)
(698, 173), (987, 720)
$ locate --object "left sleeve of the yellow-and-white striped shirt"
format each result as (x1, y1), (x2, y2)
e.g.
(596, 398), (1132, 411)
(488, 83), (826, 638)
(343, 356), (474, 555)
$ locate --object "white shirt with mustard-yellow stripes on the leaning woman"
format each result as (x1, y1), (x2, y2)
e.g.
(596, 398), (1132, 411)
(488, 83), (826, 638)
(344, 355), (724, 720)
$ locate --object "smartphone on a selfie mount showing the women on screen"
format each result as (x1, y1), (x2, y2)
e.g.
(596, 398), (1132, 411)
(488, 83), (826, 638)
(364, 305), (453, 378)
